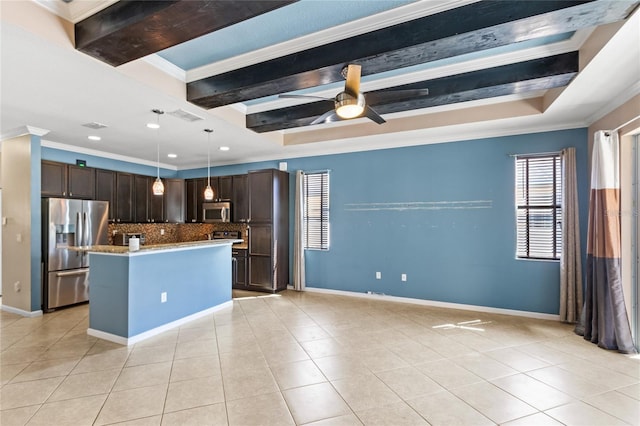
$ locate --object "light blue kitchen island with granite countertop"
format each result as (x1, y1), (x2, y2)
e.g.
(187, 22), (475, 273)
(84, 240), (242, 345)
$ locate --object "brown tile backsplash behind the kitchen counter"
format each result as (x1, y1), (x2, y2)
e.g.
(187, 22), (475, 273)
(109, 223), (247, 244)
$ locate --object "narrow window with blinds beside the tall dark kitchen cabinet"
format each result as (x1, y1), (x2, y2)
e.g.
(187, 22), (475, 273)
(304, 171), (329, 250)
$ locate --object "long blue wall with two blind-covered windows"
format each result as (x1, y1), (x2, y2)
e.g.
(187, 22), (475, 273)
(43, 128), (588, 314)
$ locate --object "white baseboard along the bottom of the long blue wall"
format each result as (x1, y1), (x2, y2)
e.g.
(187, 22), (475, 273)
(302, 287), (560, 321)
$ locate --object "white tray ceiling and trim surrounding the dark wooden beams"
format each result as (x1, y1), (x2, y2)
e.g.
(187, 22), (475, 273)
(0, 0), (640, 169)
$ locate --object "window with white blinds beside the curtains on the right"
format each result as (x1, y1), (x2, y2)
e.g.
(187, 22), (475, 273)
(516, 154), (562, 259)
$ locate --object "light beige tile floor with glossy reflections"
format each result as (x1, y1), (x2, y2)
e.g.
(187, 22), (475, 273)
(0, 291), (640, 426)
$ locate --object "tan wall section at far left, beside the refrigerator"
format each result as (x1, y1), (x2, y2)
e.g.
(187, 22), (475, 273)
(0, 135), (31, 312)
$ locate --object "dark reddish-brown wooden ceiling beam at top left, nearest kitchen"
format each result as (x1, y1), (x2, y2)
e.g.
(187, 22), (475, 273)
(75, 0), (298, 66)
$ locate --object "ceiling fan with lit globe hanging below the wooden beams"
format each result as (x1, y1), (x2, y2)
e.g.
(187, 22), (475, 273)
(279, 64), (429, 124)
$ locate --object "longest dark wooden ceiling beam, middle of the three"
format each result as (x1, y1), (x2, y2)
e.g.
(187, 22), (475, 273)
(187, 0), (636, 108)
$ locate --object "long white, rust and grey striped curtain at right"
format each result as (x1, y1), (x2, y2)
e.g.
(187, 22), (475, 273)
(576, 131), (635, 353)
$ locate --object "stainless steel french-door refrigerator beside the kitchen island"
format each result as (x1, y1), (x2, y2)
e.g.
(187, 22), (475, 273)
(42, 198), (109, 312)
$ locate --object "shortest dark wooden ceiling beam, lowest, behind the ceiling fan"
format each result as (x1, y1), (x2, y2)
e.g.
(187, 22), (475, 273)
(246, 52), (579, 133)
